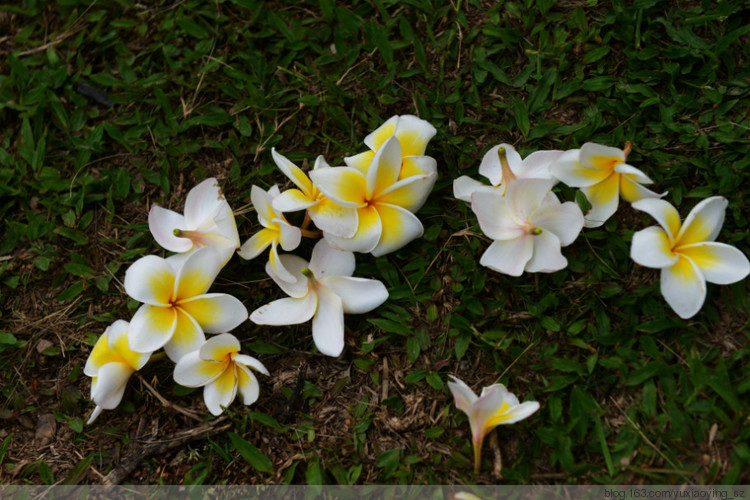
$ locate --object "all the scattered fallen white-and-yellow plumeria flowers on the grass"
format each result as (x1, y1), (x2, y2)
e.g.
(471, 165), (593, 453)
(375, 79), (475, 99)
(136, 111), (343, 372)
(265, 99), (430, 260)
(85, 115), (750, 471)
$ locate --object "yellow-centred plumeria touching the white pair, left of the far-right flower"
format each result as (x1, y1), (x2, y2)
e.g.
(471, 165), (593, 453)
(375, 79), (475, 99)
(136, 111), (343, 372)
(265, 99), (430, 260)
(550, 142), (666, 227)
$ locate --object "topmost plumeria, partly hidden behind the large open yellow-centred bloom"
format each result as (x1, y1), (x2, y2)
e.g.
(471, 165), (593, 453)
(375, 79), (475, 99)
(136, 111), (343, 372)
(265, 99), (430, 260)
(344, 115), (437, 179)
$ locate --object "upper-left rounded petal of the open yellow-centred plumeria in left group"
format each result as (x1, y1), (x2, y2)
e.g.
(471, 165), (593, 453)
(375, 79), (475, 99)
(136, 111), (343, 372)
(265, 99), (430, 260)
(125, 255), (176, 306)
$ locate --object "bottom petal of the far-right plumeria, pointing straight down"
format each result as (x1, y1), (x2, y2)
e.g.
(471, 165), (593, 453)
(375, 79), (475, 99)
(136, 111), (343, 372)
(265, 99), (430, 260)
(661, 256), (706, 319)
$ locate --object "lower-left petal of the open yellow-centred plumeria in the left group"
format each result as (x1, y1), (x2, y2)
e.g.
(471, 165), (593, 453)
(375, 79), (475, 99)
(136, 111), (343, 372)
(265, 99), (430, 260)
(128, 304), (177, 352)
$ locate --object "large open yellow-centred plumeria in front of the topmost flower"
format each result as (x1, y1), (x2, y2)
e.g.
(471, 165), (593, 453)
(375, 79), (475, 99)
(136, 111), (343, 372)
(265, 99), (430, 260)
(310, 136), (435, 257)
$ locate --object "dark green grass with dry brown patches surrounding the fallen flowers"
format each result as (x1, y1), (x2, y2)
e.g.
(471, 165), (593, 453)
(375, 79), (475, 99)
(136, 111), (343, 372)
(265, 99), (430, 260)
(0, 0), (750, 484)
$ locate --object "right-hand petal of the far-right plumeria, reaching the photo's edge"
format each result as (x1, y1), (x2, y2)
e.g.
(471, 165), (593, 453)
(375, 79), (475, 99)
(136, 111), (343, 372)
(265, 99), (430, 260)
(676, 241), (750, 285)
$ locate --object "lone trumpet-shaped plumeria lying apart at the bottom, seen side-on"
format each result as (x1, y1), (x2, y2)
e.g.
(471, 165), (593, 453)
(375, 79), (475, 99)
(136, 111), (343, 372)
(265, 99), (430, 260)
(448, 375), (539, 472)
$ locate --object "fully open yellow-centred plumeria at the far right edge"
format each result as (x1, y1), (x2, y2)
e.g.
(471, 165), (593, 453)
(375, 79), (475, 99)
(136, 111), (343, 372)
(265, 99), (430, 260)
(630, 196), (750, 319)
